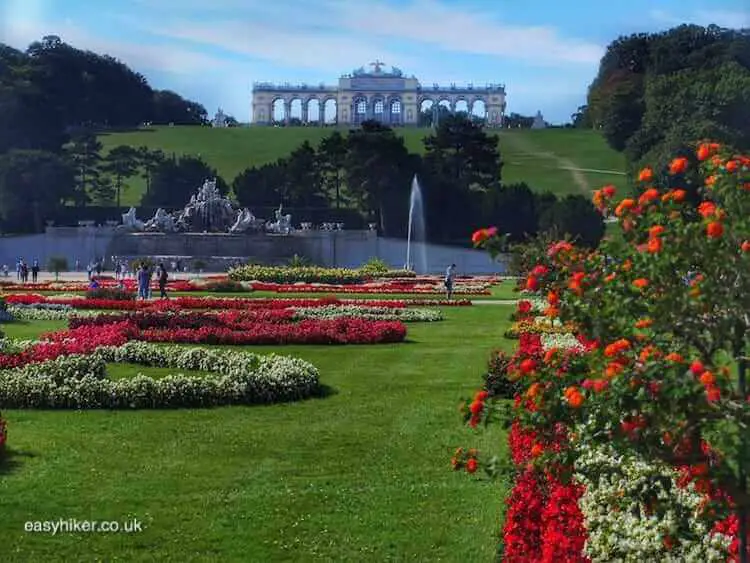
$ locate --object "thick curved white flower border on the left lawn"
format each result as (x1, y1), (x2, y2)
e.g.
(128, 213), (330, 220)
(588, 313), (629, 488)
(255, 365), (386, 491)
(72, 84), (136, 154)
(0, 342), (319, 409)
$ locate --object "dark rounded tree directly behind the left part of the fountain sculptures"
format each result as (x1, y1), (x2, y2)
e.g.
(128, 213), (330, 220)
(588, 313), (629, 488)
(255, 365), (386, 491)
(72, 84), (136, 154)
(141, 156), (229, 209)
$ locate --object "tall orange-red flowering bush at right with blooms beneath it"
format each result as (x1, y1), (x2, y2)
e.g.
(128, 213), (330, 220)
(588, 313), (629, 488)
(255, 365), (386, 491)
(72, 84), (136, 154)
(462, 143), (750, 561)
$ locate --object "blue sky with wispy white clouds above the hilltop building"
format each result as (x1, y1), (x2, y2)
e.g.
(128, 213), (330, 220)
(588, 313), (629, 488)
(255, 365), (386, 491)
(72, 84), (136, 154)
(0, 0), (750, 123)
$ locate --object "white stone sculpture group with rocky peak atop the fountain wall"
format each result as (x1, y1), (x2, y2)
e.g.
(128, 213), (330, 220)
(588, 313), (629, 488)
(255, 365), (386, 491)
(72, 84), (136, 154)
(119, 180), (293, 235)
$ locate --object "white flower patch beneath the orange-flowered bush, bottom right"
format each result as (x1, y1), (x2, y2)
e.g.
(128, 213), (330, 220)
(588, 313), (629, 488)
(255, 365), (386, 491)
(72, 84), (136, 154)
(575, 447), (731, 563)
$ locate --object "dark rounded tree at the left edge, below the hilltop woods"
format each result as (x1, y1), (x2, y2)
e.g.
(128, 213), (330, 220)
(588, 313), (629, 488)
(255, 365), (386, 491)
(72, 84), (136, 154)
(0, 150), (75, 232)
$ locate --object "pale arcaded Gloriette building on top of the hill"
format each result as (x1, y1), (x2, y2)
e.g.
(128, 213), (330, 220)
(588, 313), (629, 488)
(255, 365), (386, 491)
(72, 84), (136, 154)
(252, 61), (505, 127)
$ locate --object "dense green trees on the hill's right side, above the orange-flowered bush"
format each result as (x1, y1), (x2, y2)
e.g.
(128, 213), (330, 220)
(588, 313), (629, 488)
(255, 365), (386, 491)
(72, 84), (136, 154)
(587, 25), (750, 165)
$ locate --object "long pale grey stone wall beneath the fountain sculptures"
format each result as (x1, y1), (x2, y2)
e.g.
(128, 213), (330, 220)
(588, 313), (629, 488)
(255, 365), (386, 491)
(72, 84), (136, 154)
(0, 227), (504, 274)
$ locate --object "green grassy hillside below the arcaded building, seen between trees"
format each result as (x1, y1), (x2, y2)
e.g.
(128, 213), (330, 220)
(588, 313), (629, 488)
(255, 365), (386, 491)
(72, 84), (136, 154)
(100, 127), (625, 205)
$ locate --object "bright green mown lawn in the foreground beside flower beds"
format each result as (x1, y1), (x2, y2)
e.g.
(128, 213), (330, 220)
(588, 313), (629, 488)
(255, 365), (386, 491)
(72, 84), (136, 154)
(0, 306), (513, 562)
